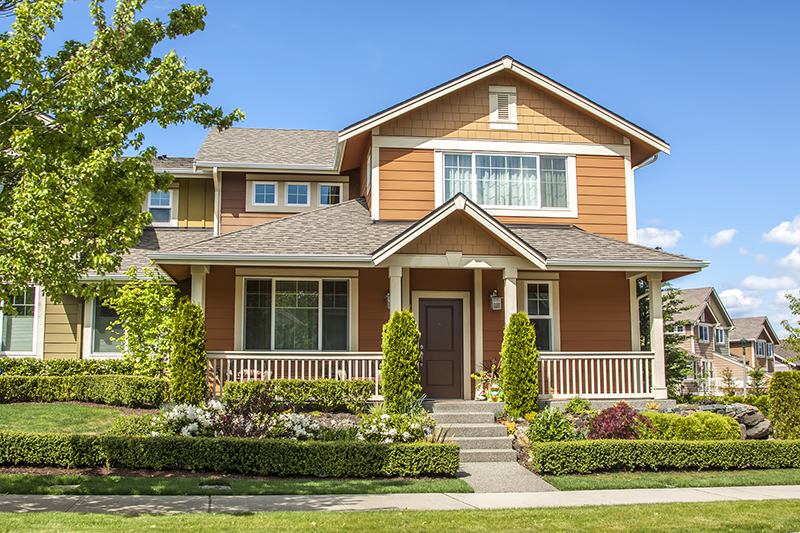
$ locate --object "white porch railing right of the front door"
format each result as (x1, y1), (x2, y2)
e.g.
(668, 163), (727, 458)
(539, 352), (655, 400)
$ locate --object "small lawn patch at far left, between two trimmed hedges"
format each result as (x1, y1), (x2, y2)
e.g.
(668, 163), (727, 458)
(0, 403), (122, 434)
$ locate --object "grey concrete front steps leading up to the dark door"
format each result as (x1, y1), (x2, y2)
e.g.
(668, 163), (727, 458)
(423, 400), (517, 463)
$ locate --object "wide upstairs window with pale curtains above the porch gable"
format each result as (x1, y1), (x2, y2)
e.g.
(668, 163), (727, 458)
(444, 153), (568, 209)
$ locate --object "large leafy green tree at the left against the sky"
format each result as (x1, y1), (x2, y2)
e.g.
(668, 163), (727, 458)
(0, 0), (244, 305)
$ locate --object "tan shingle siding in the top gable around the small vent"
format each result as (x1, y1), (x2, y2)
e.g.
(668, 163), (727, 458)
(381, 73), (623, 144)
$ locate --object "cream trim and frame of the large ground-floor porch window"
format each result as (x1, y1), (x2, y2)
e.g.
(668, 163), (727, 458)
(234, 276), (350, 354)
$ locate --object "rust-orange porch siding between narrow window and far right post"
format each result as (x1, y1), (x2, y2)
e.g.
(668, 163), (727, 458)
(558, 272), (631, 352)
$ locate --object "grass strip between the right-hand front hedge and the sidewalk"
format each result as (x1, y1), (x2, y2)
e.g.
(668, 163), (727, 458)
(543, 468), (800, 490)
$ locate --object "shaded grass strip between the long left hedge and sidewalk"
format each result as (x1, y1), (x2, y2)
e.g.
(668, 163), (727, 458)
(0, 474), (473, 495)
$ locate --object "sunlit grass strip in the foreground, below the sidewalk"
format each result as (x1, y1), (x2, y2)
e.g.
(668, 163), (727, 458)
(0, 500), (800, 533)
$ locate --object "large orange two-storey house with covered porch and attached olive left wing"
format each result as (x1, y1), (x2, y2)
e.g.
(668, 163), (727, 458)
(3, 57), (708, 400)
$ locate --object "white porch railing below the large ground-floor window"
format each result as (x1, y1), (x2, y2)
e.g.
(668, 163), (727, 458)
(206, 352), (383, 398)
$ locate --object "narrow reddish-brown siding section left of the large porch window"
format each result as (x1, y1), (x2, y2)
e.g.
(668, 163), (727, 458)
(206, 266), (236, 351)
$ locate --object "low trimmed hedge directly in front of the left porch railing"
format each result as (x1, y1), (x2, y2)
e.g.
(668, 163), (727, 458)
(222, 379), (375, 414)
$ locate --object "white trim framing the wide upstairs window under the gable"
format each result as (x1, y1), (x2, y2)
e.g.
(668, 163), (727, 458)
(434, 150), (578, 218)
